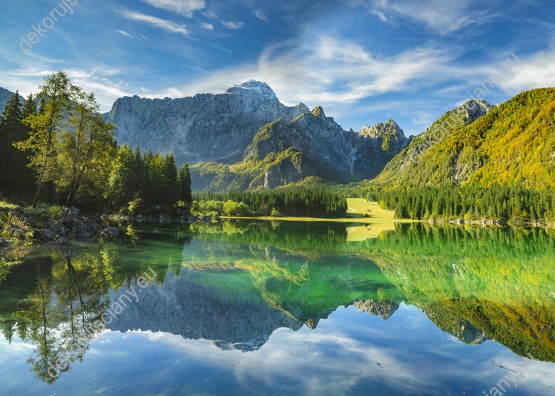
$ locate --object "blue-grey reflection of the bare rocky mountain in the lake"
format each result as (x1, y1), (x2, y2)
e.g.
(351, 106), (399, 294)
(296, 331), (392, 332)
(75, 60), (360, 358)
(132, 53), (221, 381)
(108, 270), (303, 352)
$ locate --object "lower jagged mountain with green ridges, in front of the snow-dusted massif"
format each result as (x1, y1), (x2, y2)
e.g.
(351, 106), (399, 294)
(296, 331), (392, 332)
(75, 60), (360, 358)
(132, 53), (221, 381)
(192, 107), (408, 191)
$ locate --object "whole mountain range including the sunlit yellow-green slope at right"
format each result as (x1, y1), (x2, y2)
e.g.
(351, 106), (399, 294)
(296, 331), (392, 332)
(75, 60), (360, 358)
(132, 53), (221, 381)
(0, 80), (555, 191)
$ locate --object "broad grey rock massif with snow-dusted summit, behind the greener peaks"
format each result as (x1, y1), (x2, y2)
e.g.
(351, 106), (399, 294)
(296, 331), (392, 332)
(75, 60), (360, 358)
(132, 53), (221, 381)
(105, 81), (308, 163)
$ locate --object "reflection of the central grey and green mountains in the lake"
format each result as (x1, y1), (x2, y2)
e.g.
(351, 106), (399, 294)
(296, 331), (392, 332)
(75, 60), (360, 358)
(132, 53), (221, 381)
(109, 234), (402, 351)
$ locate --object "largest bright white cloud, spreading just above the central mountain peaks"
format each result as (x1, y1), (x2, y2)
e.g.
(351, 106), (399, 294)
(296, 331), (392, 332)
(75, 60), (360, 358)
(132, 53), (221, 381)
(166, 37), (456, 110)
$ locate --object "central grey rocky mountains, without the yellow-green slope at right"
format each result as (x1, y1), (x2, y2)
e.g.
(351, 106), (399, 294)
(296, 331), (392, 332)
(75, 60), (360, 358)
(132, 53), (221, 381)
(105, 80), (408, 191)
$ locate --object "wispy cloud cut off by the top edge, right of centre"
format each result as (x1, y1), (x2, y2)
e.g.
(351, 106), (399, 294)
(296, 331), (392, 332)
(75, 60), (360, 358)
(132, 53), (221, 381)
(370, 0), (495, 34)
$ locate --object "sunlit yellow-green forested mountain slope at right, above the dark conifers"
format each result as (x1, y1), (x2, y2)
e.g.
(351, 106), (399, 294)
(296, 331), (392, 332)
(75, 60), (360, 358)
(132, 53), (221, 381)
(375, 88), (555, 190)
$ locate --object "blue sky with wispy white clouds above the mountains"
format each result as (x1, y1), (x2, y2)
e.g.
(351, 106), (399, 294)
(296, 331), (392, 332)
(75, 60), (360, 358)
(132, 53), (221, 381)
(0, 0), (555, 135)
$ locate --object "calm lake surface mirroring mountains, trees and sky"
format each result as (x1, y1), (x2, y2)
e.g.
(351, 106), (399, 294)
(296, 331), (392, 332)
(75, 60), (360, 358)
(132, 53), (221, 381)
(0, 221), (555, 395)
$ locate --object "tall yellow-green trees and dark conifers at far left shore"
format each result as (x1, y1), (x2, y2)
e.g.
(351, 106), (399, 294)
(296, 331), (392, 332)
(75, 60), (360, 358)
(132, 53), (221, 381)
(4, 72), (116, 208)
